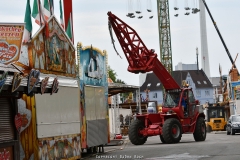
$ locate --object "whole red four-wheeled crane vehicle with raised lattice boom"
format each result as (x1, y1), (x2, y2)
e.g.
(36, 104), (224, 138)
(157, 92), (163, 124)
(108, 12), (206, 145)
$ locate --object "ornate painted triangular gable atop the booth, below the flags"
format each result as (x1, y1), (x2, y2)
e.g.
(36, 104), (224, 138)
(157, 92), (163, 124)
(30, 16), (76, 77)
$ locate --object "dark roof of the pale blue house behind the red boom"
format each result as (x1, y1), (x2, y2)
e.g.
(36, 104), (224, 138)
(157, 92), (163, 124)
(140, 69), (212, 92)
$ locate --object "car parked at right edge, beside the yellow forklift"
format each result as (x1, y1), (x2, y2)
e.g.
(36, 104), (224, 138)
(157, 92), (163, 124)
(227, 114), (240, 135)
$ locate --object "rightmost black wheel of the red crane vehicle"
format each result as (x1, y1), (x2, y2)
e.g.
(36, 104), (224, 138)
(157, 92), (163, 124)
(193, 117), (207, 141)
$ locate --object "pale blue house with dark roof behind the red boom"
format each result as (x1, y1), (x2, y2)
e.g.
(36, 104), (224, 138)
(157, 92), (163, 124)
(140, 70), (214, 105)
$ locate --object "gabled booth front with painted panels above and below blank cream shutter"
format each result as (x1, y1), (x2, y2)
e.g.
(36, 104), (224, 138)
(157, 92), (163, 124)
(29, 16), (81, 159)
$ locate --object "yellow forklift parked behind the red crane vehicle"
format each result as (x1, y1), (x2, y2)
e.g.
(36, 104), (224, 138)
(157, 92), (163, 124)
(206, 106), (227, 132)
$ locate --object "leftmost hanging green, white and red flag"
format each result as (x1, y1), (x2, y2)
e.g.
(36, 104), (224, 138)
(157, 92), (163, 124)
(23, 0), (32, 43)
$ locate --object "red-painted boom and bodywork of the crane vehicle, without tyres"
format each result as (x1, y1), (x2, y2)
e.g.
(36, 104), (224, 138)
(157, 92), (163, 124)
(108, 12), (204, 142)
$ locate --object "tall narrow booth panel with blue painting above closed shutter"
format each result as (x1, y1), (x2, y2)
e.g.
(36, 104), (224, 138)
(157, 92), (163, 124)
(77, 43), (110, 149)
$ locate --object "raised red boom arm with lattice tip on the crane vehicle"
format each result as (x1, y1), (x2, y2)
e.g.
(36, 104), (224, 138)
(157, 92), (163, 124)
(108, 12), (180, 89)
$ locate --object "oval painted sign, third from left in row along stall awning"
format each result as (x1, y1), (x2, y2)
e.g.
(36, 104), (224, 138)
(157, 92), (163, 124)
(27, 69), (40, 94)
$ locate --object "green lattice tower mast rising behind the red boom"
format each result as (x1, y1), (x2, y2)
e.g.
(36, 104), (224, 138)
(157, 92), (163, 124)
(157, 0), (173, 74)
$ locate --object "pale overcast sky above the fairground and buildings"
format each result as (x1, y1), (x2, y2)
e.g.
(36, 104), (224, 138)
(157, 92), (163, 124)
(0, 0), (240, 85)
